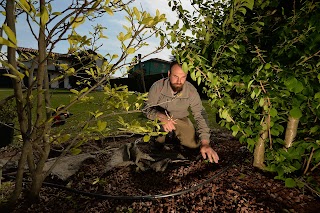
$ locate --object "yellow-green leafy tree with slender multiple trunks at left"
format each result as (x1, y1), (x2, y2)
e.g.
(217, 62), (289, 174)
(0, 0), (168, 202)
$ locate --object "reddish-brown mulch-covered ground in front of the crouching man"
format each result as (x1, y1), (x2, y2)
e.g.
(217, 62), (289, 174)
(0, 130), (320, 213)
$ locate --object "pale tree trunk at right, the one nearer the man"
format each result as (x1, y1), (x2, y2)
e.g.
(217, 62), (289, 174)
(253, 116), (270, 170)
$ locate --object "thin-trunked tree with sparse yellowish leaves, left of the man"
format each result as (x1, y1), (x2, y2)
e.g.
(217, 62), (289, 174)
(0, 0), (166, 203)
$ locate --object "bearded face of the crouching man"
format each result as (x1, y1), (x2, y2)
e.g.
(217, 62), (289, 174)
(168, 64), (187, 92)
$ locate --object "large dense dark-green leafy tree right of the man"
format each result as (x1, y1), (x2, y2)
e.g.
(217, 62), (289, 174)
(169, 0), (320, 186)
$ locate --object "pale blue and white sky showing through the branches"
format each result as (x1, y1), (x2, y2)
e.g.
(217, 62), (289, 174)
(0, 0), (191, 76)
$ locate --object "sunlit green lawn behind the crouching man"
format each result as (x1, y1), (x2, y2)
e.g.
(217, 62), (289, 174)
(0, 89), (217, 141)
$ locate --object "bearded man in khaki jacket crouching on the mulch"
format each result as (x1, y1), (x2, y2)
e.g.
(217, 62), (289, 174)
(144, 62), (219, 163)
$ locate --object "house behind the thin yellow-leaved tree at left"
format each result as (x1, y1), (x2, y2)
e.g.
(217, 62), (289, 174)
(0, 47), (105, 89)
